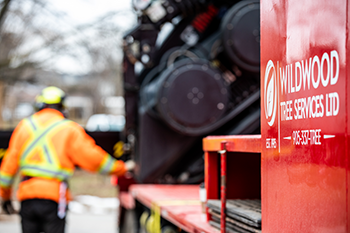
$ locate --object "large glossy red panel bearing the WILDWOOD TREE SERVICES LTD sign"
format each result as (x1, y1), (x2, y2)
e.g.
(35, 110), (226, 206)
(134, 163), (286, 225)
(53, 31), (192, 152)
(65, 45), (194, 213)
(261, 0), (350, 233)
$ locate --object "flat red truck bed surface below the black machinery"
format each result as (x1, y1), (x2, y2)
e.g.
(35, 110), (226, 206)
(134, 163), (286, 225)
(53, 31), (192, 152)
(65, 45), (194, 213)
(130, 184), (220, 233)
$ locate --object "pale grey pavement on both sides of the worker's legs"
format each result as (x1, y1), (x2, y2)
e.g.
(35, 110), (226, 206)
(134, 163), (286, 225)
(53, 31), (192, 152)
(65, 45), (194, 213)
(0, 198), (117, 233)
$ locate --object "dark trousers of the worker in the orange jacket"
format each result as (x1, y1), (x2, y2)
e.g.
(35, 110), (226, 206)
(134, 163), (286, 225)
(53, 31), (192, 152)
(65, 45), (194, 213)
(20, 199), (66, 233)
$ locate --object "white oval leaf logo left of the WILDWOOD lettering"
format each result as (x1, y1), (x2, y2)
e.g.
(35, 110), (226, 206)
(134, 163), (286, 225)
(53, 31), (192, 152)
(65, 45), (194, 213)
(264, 60), (277, 126)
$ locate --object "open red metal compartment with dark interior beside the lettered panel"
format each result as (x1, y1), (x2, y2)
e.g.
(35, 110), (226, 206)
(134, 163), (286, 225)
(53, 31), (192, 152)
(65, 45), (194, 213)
(203, 135), (261, 224)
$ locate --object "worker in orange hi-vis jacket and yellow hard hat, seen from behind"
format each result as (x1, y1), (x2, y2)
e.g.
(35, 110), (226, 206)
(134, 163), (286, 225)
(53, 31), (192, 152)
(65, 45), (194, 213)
(0, 87), (135, 233)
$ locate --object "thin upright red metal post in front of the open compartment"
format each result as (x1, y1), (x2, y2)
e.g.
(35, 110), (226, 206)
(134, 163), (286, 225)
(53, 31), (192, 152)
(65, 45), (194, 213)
(220, 141), (227, 233)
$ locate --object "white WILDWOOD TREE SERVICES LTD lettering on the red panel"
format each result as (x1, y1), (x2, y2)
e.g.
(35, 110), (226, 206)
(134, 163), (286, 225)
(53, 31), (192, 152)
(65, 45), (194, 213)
(268, 50), (340, 124)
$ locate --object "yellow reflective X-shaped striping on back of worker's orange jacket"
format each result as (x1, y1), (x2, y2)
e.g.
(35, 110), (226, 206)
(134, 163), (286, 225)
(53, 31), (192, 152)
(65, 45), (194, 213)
(20, 116), (73, 181)
